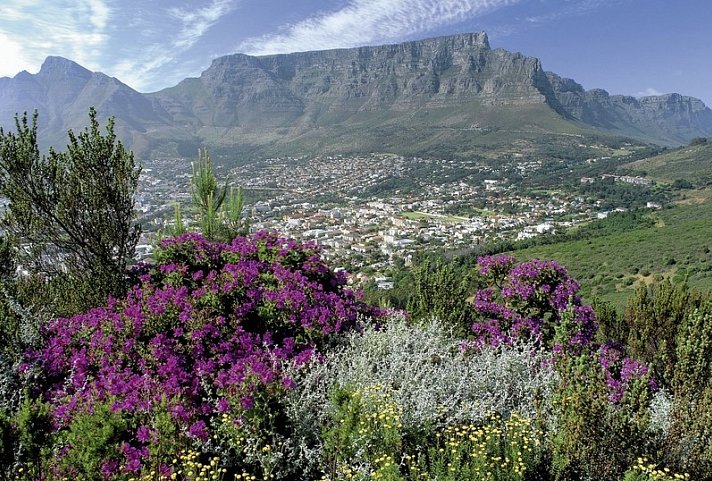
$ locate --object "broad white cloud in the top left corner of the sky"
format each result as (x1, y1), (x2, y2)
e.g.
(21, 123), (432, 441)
(0, 0), (111, 75)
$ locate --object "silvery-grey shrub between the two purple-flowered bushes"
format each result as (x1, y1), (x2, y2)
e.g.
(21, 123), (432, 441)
(285, 319), (556, 478)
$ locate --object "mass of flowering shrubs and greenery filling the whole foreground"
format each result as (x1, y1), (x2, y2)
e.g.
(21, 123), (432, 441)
(0, 113), (712, 481)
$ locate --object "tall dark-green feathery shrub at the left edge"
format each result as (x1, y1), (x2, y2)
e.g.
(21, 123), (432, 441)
(0, 108), (141, 314)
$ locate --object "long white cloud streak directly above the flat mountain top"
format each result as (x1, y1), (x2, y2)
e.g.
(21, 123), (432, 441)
(237, 0), (520, 55)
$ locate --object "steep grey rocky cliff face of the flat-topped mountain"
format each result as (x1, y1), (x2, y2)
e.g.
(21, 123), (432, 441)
(153, 33), (555, 128)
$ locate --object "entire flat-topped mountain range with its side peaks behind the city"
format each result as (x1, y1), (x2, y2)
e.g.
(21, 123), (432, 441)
(0, 32), (712, 155)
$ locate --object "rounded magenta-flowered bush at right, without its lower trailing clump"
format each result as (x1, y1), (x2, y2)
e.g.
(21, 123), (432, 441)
(472, 256), (597, 346)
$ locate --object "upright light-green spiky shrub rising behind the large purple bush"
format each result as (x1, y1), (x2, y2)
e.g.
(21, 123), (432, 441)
(188, 149), (249, 241)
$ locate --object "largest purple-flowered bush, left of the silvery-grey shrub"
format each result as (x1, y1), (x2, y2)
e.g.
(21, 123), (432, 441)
(25, 233), (374, 478)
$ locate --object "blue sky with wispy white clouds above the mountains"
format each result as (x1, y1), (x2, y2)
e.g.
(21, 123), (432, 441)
(0, 0), (712, 105)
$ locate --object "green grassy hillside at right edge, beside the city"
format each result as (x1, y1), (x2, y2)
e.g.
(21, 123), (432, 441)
(508, 199), (712, 307)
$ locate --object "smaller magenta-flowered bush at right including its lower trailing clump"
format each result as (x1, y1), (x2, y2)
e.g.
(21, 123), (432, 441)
(467, 256), (657, 404)
